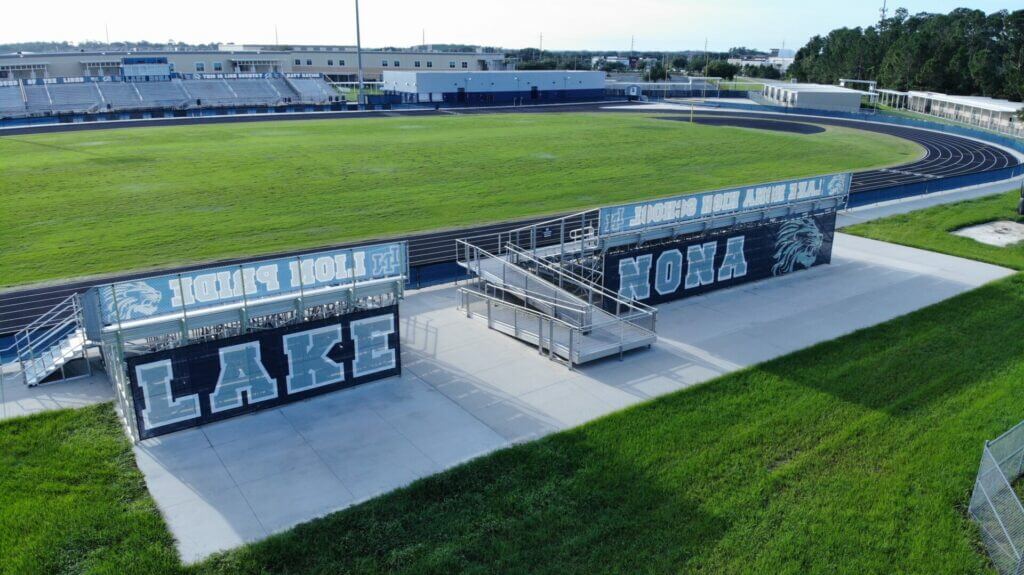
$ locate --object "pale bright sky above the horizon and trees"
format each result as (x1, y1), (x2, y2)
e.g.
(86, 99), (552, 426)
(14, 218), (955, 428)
(0, 0), (1019, 51)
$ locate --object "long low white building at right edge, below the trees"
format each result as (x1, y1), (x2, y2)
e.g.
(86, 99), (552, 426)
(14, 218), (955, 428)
(903, 91), (1024, 136)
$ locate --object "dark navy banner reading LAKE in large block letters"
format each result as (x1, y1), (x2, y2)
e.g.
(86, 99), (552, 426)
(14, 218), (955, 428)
(125, 305), (401, 439)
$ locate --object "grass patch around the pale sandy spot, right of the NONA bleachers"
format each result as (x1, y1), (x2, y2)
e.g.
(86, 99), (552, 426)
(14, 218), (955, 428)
(843, 190), (1024, 270)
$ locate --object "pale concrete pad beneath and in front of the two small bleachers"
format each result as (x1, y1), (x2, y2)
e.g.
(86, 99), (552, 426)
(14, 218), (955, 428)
(125, 234), (1012, 562)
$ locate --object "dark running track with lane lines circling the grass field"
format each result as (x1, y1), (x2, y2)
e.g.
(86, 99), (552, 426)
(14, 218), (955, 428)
(0, 102), (1018, 333)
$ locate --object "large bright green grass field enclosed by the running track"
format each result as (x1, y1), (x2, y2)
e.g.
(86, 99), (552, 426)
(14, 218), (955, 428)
(0, 114), (921, 285)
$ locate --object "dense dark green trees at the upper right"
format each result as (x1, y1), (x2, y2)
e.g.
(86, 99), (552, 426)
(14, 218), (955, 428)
(788, 8), (1024, 101)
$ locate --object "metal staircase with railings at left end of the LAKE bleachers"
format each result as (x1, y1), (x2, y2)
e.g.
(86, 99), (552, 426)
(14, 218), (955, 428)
(0, 294), (91, 387)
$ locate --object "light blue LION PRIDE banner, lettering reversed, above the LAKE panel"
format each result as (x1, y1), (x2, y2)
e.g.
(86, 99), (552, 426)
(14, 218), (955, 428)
(98, 241), (409, 325)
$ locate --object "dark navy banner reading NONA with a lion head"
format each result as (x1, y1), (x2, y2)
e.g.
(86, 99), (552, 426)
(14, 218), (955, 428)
(604, 210), (836, 304)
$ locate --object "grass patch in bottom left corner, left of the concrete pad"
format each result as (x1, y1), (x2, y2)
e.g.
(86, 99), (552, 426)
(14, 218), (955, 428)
(0, 404), (178, 575)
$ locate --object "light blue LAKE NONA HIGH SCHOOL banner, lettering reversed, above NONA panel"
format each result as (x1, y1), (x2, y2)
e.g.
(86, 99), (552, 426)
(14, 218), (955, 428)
(598, 174), (852, 235)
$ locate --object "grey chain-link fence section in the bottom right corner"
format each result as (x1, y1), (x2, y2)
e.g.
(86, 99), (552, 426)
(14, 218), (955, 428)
(969, 415), (1024, 575)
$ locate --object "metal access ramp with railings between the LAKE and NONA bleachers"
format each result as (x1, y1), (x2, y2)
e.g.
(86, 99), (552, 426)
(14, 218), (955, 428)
(457, 240), (657, 367)
